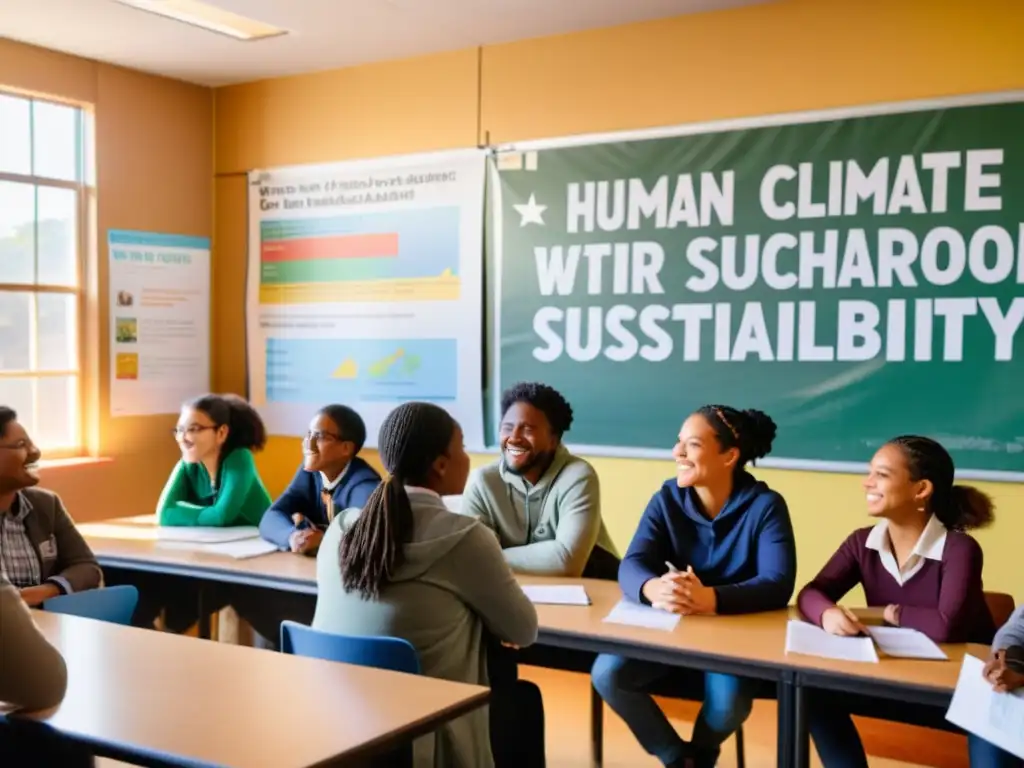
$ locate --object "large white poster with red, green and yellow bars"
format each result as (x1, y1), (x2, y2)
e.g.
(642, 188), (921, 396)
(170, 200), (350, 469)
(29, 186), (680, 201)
(246, 150), (485, 447)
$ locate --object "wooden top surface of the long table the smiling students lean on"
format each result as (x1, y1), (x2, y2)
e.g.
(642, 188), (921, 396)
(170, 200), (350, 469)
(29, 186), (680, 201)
(82, 515), (988, 692)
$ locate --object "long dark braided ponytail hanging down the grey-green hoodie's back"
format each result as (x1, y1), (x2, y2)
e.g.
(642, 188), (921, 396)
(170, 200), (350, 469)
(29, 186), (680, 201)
(339, 475), (413, 600)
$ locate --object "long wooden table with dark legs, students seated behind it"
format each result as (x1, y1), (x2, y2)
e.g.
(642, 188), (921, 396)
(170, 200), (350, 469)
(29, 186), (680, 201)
(82, 520), (974, 768)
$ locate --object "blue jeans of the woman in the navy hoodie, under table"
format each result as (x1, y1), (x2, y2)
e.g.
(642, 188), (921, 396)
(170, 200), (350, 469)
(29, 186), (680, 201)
(591, 654), (755, 766)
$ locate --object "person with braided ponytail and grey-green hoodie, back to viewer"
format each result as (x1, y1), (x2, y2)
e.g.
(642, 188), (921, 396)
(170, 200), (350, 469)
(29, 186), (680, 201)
(312, 402), (537, 768)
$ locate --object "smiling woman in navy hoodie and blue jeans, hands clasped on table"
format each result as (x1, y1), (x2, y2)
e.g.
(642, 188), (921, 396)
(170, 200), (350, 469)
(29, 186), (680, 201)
(592, 406), (797, 768)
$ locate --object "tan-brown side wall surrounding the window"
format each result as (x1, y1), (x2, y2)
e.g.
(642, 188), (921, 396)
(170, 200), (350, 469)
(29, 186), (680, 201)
(0, 39), (213, 521)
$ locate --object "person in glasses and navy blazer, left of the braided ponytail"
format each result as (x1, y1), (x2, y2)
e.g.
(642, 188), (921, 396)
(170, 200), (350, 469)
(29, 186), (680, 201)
(232, 406), (381, 649)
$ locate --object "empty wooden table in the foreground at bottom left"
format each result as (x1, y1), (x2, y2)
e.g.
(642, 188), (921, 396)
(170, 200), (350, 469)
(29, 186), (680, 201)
(24, 611), (488, 768)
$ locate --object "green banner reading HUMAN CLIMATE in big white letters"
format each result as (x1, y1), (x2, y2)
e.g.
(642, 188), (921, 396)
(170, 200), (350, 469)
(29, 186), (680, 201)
(492, 101), (1024, 479)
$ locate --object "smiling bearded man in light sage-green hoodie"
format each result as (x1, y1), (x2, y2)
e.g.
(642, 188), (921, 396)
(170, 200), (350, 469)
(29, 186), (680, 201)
(460, 384), (618, 579)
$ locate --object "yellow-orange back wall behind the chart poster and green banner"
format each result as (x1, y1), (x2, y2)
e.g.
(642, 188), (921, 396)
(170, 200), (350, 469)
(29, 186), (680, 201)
(214, 0), (1024, 600)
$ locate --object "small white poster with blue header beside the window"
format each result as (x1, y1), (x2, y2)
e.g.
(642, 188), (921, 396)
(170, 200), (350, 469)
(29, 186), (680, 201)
(108, 229), (210, 417)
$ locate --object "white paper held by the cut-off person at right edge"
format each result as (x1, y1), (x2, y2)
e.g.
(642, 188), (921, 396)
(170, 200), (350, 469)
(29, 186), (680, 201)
(946, 655), (1024, 760)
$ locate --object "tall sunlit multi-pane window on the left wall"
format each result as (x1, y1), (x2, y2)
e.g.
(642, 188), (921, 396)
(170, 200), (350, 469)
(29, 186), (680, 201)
(0, 91), (88, 456)
